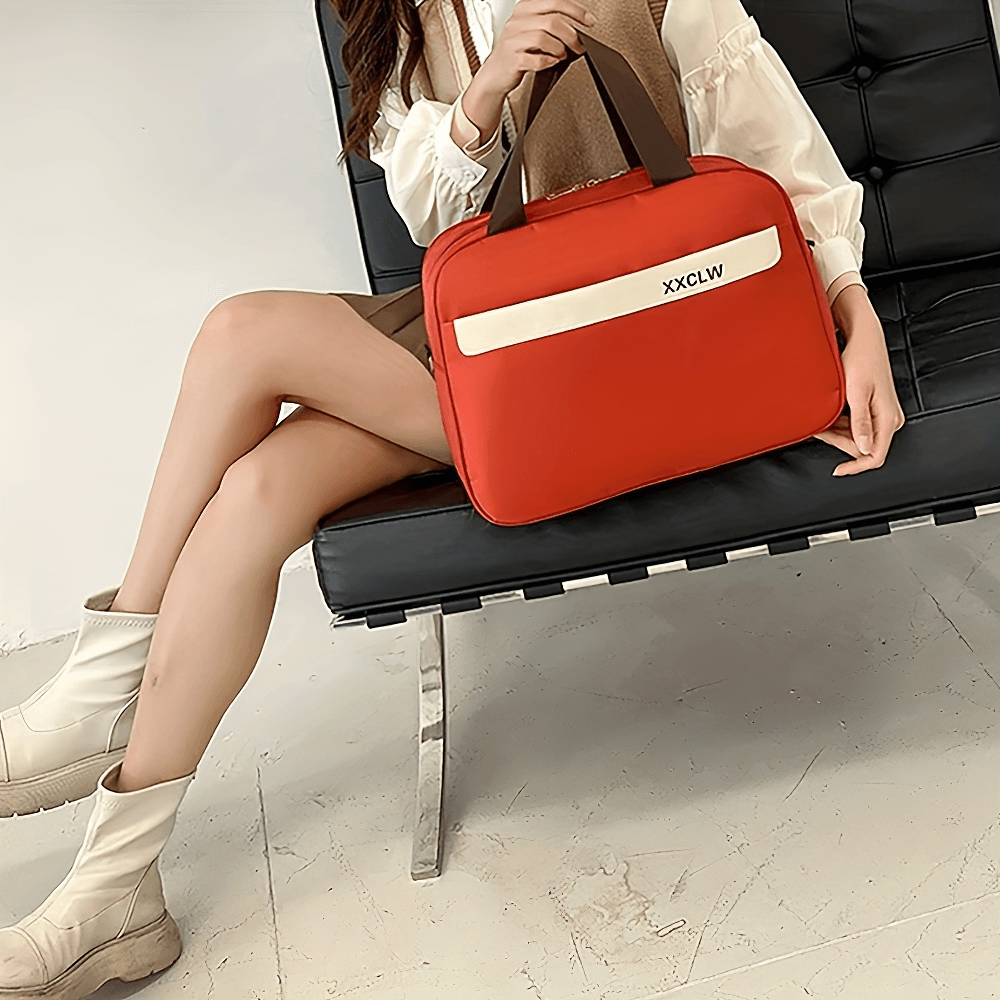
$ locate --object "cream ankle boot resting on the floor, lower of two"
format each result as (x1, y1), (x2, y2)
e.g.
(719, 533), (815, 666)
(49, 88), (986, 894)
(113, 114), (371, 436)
(0, 763), (195, 1000)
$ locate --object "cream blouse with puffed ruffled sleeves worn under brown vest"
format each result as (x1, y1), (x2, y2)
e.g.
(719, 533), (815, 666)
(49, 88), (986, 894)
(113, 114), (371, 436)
(369, 0), (865, 303)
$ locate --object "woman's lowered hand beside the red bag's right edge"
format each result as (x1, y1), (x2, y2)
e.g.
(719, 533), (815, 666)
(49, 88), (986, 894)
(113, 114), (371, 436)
(816, 285), (906, 476)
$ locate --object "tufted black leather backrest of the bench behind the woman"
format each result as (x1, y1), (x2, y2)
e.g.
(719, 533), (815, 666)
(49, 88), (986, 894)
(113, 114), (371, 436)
(317, 0), (1000, 294)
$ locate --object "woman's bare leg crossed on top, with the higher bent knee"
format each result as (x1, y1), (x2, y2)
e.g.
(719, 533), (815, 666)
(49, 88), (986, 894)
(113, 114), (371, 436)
(111, 291), (453, 616)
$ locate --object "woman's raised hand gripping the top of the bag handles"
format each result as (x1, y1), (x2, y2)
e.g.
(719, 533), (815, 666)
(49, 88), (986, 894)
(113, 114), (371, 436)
(477, 0), (597, 95)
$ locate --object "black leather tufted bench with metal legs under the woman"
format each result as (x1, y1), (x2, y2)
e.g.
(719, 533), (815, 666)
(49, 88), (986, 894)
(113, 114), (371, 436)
(313, 0), (1000, 879)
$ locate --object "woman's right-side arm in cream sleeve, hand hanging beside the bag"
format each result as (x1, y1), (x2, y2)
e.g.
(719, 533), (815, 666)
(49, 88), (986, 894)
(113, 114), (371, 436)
(661, 0), (903, 476)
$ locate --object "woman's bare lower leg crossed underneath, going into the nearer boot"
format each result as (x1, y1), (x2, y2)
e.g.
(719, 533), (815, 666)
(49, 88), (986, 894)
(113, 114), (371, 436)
(111, 402), (441, 791)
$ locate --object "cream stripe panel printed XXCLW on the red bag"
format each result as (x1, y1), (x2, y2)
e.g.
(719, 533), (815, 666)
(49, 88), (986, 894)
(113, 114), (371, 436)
(454, 226), (781, 356)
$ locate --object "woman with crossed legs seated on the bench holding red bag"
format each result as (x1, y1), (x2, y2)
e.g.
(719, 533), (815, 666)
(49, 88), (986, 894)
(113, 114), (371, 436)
(0, 0), (902, 1000)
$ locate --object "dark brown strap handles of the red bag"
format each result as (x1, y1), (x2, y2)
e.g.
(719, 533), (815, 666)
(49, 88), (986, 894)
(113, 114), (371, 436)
(482, 30), (695, 236)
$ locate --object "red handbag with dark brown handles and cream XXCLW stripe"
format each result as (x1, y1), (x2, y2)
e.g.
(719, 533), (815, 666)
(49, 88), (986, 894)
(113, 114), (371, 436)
(422, 33), (846, 525)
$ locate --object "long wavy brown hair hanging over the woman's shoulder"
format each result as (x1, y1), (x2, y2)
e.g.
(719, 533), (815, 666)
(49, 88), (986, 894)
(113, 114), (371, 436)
(327, 0), (424, 164)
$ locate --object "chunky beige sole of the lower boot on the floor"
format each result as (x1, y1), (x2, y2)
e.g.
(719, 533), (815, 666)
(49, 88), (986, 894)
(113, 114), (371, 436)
(0, 910), (181, 1000)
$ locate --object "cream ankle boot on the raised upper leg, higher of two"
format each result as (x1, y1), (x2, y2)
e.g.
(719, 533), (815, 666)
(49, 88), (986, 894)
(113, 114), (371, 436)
(0, 587), (158, 816)
